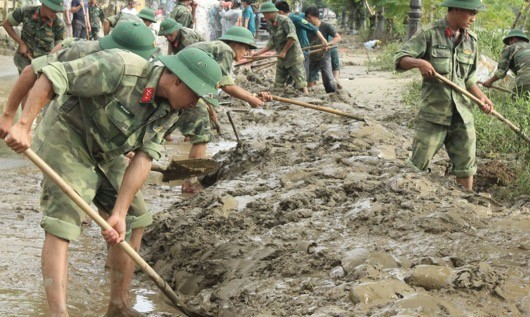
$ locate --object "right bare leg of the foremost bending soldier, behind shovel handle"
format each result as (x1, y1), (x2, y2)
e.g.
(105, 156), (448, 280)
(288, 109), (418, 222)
(105, 228), (144, 317)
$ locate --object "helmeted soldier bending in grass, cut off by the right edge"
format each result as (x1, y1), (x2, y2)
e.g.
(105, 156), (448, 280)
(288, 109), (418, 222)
(483, 29), (530, 97)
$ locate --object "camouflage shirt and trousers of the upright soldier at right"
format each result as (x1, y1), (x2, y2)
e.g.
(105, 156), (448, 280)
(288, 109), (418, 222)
(394, 19), (478, 177)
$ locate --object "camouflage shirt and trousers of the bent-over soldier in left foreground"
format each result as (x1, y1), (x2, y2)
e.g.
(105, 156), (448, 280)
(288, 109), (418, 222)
(33, 49), (183, 240)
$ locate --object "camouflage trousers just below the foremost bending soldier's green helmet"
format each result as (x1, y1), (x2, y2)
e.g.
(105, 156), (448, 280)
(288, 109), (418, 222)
(171, 99), (212, 144)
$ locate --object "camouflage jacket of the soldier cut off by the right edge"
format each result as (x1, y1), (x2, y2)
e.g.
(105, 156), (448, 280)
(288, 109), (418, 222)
(495, 42), (530, 87)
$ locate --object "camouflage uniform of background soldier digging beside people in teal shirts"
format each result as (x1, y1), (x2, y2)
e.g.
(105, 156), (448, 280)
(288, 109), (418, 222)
(267, 15), (307, 89)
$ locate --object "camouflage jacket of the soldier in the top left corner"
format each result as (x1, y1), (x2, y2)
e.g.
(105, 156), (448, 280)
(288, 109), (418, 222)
(7, 6), (66, 58)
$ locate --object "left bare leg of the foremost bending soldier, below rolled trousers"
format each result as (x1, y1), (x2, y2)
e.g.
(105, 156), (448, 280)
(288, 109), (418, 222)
(41, 233), (69, 317)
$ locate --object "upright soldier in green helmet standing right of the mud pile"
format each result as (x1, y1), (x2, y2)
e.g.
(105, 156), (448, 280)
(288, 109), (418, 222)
(394, 0), (493, 190)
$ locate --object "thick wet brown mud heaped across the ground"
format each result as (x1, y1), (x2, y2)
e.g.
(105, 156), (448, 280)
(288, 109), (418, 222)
(0, 33), (530, 316)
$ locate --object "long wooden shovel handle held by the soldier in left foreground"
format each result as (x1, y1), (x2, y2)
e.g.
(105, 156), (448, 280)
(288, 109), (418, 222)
(24, 149), (200, 316)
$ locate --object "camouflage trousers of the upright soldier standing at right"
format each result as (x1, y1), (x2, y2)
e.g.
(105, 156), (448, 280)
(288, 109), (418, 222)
(410, 111), (477, 177)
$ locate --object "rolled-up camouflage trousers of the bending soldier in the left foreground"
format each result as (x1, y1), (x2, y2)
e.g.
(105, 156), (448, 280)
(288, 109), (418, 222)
(32, 103), (153, 241)
